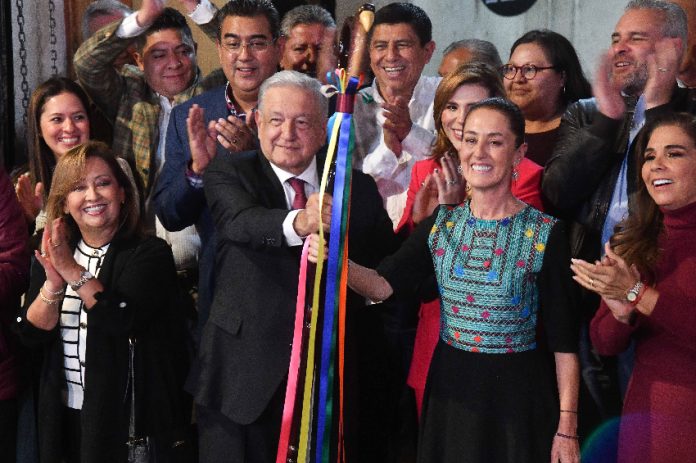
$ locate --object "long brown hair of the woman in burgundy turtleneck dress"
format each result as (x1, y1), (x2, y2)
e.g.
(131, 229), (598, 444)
(609, 113), (696, 281)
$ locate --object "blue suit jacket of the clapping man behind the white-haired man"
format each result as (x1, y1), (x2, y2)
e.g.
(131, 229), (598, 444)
(153, 85), (227, 338)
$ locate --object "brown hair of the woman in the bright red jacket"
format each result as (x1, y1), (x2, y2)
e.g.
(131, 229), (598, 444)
(430, 61), (505, 160)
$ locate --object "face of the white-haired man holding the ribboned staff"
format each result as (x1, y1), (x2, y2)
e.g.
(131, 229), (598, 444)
(255, 86), (326, 175)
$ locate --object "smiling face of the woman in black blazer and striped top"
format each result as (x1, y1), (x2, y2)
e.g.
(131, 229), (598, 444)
(64, 157), (125, 244)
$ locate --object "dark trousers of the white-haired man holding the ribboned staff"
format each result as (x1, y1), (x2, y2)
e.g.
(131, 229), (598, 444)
(196, 381), (286, 463)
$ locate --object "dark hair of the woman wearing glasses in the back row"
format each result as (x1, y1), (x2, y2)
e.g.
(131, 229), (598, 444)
(510, 29), (592, 106)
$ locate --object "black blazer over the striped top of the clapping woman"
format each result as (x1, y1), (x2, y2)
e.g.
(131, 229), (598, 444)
(19, 237), (190, 463)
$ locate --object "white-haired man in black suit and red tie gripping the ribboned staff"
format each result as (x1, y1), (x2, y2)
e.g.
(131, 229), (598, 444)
(189, 71), (395, 462)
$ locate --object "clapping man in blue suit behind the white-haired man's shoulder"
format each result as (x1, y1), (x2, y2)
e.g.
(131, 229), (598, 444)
(153, 0), (280, 334)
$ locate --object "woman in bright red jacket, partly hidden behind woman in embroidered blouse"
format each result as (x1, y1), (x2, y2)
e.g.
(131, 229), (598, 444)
(397, 62), (543, 416)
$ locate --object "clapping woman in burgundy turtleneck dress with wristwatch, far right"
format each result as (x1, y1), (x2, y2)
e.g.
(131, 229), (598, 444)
(572, 114), (696, 463)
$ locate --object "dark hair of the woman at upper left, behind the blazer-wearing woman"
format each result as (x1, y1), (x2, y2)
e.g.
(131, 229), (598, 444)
(27, 77), (92, 199)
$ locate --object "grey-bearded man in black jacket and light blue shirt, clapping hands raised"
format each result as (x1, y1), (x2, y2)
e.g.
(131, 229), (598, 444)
(542, 0), (696, 444)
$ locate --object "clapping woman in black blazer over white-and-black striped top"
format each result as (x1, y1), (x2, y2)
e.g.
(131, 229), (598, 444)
(20, 142), (185, 463)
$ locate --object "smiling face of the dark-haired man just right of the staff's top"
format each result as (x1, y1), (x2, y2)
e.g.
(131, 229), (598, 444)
(370, 23), (435, 101)
